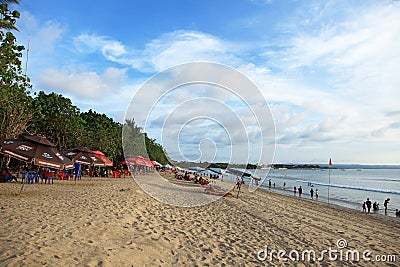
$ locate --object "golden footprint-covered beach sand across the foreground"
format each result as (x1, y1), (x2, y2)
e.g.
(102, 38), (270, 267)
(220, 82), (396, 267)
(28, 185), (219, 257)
(0, 174), (400, 266)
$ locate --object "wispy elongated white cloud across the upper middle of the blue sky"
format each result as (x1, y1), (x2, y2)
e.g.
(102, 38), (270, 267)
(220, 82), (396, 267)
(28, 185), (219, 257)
(74, 31), (239, 72)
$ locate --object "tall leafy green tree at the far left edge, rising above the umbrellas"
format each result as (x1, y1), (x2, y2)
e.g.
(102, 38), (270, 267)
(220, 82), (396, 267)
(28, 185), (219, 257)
(0, 4), (32, 138)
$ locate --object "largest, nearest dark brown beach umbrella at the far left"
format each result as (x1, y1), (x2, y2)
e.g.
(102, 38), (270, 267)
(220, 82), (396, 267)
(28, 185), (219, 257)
(0, 136), (73, 169)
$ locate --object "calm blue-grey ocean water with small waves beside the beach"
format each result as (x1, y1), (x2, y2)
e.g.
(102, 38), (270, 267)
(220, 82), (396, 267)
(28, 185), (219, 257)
(227, 168), (400, 219)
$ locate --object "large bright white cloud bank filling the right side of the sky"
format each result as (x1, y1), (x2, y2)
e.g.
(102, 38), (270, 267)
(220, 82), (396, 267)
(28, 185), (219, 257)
(253, 1), (400, 150)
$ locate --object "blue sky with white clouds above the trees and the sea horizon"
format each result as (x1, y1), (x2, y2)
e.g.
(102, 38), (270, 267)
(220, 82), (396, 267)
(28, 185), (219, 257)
(12, 0), (400, 164)
